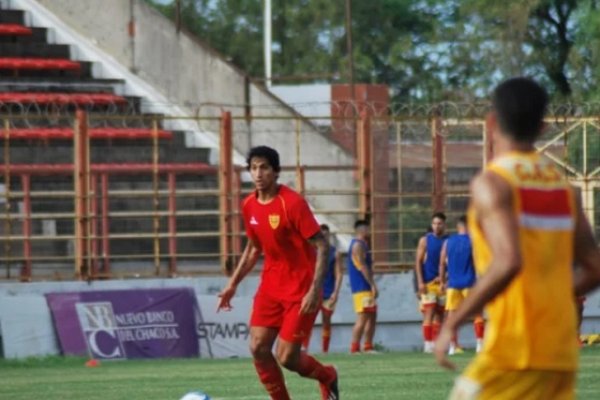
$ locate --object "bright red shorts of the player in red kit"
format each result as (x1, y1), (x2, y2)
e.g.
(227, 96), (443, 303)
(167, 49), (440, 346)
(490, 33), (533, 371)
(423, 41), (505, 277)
(250, 292), (317, 343)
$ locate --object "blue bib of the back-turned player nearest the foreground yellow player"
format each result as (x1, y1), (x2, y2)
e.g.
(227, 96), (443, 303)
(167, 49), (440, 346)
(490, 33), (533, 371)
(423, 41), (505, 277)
(446, 234), (475, 289)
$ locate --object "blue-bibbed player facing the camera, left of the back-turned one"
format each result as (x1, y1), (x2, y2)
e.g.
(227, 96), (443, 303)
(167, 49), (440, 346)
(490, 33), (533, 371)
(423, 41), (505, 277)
(415, 212), (446, 353)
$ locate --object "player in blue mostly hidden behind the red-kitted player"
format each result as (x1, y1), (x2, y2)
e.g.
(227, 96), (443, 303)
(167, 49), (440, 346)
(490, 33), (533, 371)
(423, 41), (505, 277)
(304, 224), (344, 353)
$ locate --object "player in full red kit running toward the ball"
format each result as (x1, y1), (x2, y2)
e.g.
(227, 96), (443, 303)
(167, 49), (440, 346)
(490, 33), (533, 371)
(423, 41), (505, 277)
(218, 146), (339, 400)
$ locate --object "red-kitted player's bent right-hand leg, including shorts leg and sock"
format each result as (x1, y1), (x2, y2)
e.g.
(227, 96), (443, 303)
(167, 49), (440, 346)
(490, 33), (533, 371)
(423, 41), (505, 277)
(276, 302), (339, 400)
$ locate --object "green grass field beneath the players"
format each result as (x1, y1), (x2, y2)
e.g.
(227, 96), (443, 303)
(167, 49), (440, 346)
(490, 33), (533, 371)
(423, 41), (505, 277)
(0, 348), (600, 400)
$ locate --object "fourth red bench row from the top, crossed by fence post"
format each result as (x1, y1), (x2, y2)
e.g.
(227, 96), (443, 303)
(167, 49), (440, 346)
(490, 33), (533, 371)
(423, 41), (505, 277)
(0, 128), (173, 140)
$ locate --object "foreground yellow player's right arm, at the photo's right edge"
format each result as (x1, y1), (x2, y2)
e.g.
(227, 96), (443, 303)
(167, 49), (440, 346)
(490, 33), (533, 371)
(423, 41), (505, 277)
(574, 192), (600, 296)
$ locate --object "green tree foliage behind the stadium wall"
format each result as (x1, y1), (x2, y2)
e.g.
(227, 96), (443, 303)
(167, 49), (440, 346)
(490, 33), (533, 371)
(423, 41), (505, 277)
(148, 0), (600, 102)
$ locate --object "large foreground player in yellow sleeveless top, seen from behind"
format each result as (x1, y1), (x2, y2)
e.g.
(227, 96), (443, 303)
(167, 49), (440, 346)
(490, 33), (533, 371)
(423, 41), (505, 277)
(435, 78), (600, 400)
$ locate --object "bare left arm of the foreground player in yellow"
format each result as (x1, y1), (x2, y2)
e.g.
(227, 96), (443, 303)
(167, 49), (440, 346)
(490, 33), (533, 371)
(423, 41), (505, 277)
(435, 172), (521, 368)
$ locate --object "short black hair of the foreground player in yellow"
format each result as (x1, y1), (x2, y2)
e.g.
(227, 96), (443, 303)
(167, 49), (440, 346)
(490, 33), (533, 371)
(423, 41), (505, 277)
(492, 77), (548, 143)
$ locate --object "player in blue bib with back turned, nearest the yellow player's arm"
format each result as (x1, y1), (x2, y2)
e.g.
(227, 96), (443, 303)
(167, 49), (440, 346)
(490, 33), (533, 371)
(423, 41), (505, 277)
(440, 215), (484, 354)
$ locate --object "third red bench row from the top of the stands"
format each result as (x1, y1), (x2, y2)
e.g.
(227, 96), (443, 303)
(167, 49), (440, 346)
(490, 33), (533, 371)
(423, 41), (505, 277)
(0, 92), (127, 105)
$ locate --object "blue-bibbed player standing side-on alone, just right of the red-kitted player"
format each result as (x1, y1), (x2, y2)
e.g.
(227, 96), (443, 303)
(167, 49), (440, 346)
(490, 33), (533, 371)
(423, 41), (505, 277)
(348, 220), (378, 353)
